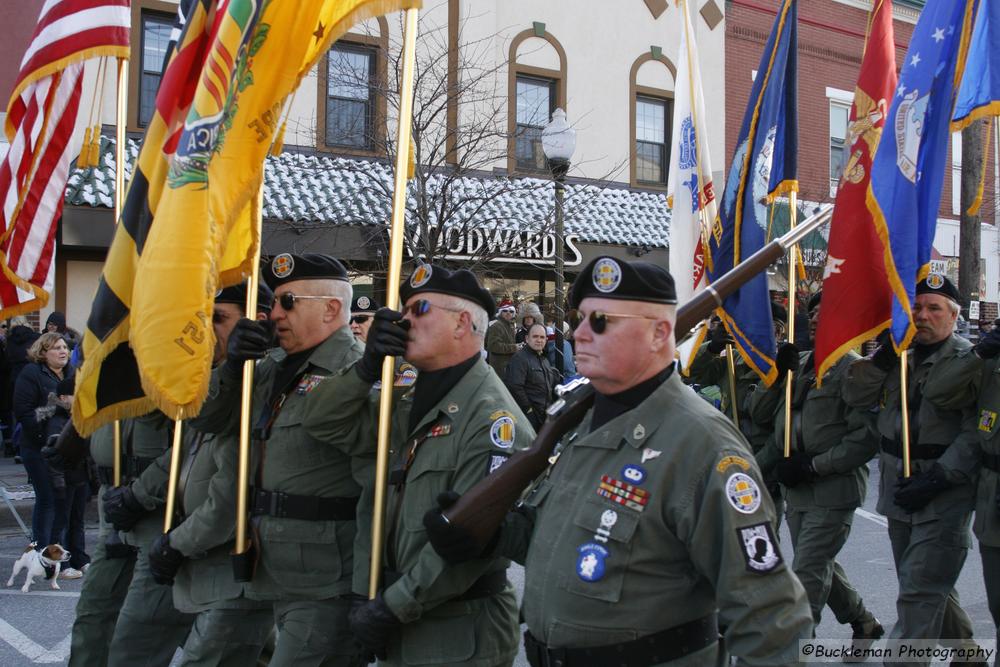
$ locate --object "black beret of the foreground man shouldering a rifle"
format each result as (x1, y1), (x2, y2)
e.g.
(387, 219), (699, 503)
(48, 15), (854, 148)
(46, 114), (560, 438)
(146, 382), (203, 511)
(569, 256), (677, 308)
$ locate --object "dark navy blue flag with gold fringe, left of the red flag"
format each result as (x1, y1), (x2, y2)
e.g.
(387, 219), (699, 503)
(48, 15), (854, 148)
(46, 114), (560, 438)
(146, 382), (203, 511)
(707, 0), (798, 385)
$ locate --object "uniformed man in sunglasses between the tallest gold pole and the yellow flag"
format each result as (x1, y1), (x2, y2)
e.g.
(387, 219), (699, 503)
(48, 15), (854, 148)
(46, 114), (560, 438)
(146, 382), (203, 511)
(193, 254), (366, 667)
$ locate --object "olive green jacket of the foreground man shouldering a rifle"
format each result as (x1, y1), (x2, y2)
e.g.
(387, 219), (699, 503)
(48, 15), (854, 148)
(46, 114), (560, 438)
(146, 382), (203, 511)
(500, 373), (812, 665)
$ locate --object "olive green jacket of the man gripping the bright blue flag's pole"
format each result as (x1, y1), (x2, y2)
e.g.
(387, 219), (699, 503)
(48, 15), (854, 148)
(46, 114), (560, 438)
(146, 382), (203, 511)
(844, 334), (978, 524)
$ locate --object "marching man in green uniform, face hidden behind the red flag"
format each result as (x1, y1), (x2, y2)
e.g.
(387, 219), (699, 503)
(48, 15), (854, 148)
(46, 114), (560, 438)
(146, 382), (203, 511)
(751, 293), (884, 641)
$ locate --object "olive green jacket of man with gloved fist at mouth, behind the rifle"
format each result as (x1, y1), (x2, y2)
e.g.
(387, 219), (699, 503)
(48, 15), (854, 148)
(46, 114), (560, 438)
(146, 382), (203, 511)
(305, 359), (535, 666)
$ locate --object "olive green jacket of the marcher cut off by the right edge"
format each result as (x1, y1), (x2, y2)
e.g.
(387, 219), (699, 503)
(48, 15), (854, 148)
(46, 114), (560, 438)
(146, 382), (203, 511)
(924, 349), (1000, 547)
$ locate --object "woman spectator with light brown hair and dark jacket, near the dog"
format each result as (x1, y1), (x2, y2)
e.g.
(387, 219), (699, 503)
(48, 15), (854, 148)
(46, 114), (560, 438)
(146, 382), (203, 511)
(14, 332), (73, 549)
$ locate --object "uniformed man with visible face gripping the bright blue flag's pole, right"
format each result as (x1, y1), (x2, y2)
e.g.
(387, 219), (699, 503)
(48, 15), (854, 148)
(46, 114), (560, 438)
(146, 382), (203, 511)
(845, 274), (979, 664)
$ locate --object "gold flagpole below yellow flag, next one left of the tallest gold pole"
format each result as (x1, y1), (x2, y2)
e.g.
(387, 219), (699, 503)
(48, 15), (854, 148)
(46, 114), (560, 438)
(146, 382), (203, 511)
(233, 184), (264, 568)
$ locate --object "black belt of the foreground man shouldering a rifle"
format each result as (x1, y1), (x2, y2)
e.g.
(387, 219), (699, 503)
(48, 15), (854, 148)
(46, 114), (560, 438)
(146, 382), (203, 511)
(524, 612), (719, 667)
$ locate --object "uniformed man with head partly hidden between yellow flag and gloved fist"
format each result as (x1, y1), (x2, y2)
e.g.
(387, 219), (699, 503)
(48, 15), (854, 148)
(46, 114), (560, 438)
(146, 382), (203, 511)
(141, 282), (274, 667)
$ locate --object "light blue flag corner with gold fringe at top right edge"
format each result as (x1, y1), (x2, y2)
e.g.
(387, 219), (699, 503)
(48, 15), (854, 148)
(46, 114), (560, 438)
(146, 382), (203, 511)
(951, 0), (1000, 131)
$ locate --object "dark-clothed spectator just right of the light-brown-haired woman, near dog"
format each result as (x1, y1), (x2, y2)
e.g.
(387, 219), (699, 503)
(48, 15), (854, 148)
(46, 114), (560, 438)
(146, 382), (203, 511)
(35, 376), (91, 579)
